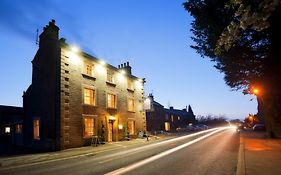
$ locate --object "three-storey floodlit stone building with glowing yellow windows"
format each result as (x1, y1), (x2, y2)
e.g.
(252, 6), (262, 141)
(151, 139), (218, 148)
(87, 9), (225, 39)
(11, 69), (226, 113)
(23, 20), (146, 150)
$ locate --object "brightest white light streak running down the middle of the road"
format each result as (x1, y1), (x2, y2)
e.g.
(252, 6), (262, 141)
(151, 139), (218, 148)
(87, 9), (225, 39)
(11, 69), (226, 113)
(106, 127), (226, 175)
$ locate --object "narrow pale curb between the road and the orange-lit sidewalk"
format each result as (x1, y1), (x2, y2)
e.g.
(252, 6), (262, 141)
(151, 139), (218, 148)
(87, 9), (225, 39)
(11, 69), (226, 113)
(236, 133), (246, 175)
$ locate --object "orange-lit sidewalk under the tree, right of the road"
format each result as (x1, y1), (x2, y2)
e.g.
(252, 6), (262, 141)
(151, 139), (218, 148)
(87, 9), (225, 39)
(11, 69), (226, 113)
(237, 130), (281, 175)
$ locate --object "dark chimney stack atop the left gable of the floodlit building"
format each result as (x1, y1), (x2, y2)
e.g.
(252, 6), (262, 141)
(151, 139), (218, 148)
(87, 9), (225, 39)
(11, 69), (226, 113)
(39, 19), (60, 47)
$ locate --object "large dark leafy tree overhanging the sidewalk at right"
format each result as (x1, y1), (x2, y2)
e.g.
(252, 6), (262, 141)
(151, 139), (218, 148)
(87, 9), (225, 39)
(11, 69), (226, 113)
(184, 0), (281, 137)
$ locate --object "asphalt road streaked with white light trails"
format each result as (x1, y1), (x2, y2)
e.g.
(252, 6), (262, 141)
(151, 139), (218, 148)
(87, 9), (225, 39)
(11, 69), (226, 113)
(0, 129), (239, 175)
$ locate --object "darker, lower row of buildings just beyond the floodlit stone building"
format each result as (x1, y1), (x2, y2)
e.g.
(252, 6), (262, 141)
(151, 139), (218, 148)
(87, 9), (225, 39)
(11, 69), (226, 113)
(145, 94), (195, 132)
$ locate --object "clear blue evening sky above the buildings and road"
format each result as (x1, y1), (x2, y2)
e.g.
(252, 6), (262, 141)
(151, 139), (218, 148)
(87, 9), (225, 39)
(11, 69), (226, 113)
(0, 0), (257, 119)
